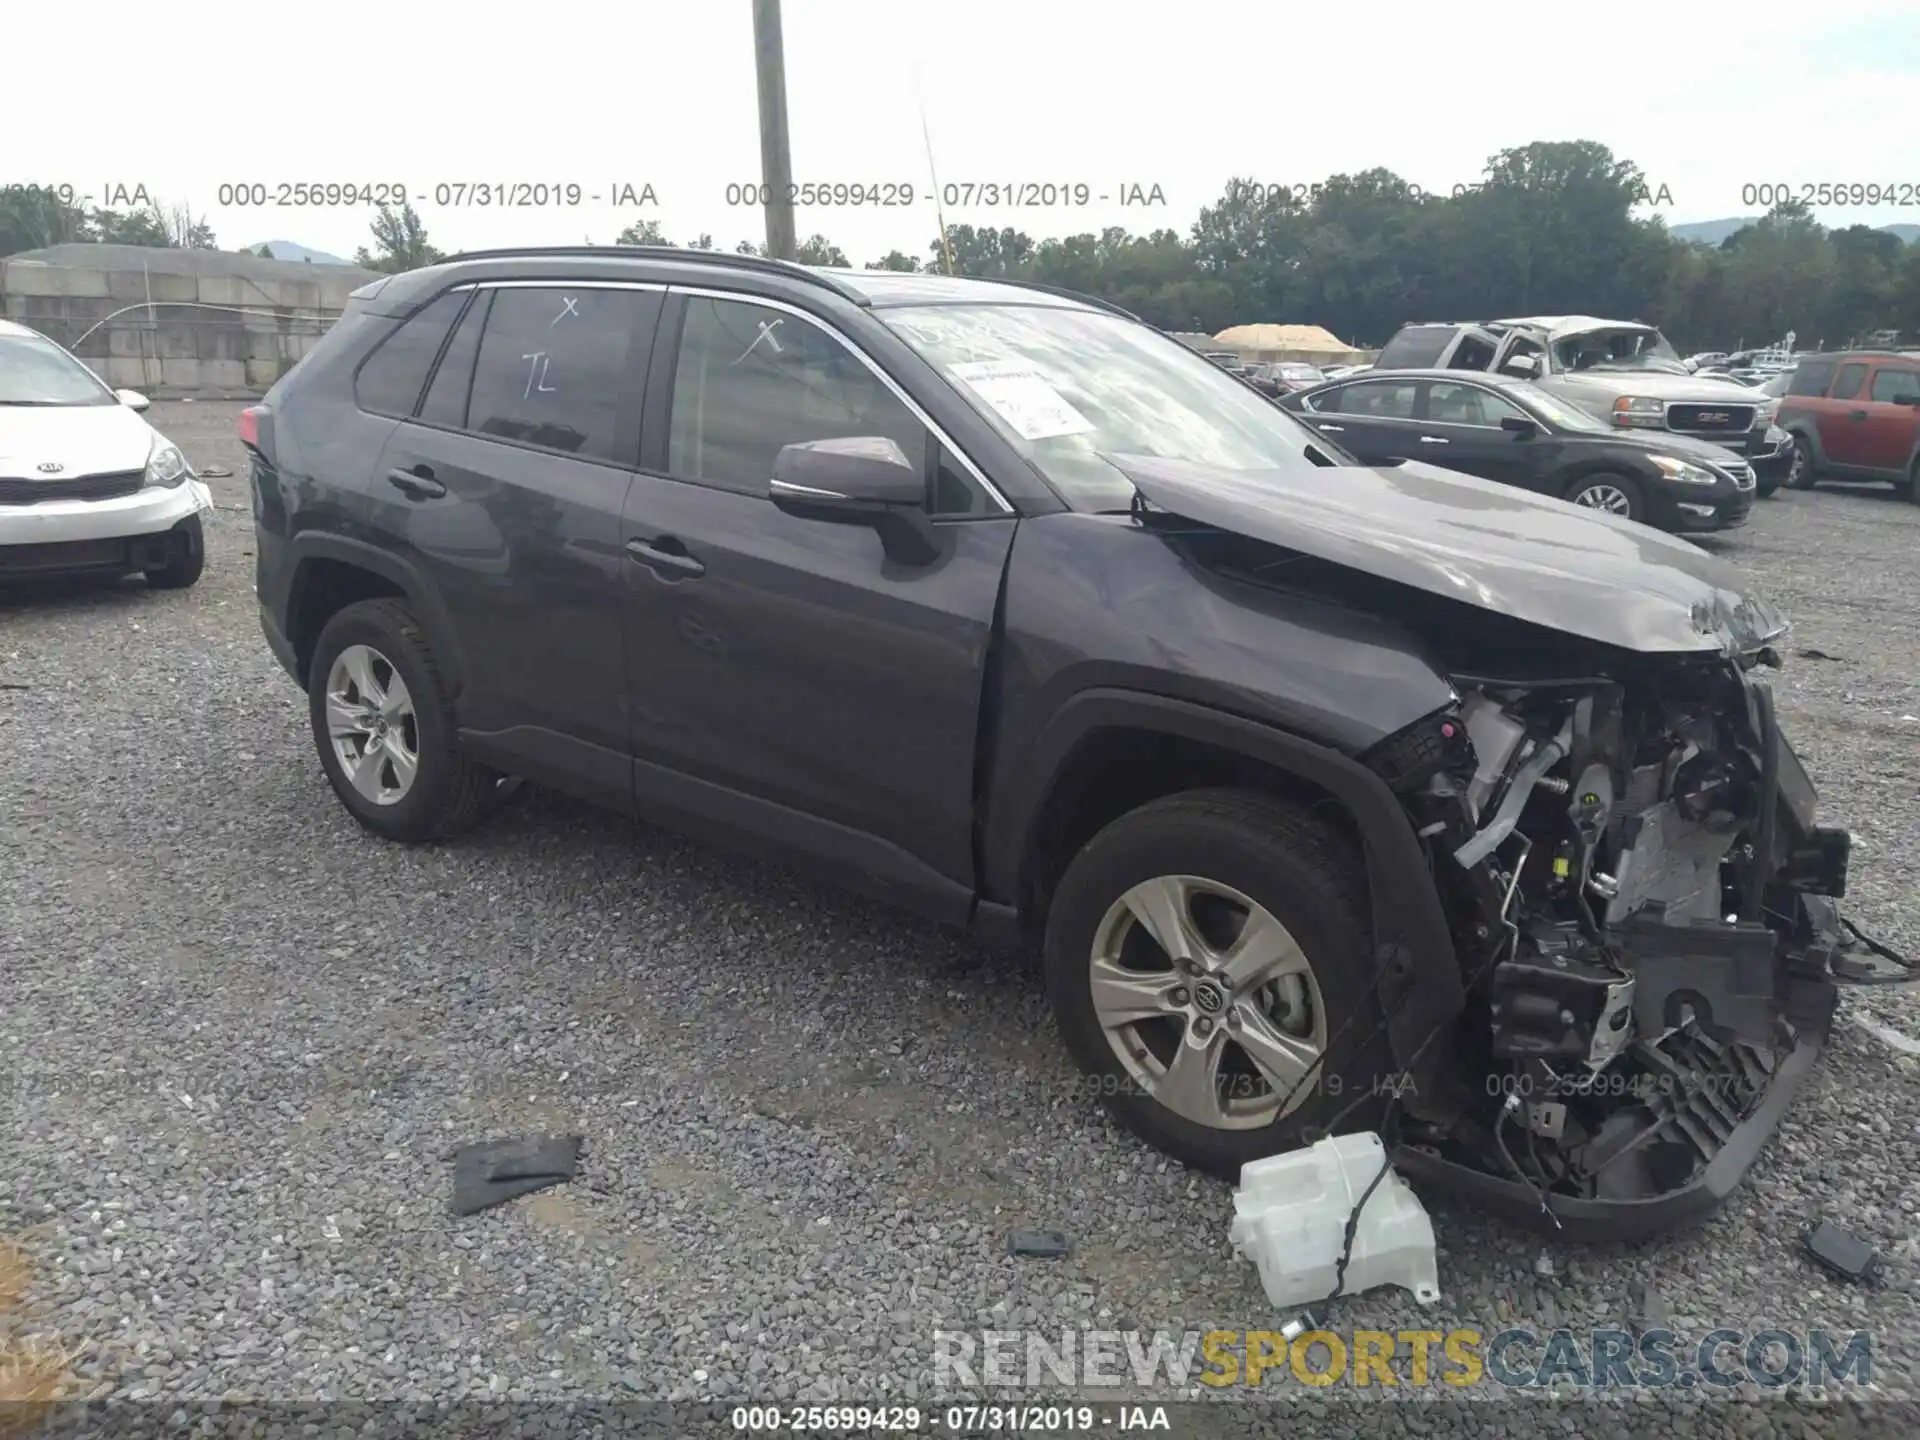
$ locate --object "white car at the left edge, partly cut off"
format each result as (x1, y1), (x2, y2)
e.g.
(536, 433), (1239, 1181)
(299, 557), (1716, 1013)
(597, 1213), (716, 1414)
(0, 321), (213, 589)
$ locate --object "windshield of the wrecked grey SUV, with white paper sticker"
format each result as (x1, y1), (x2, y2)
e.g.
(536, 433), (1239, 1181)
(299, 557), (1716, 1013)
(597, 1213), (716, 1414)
(876, 305), (1346, 511)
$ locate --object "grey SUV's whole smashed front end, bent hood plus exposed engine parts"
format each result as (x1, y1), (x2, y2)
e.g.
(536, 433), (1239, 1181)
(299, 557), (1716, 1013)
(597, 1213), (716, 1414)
(1075, 457), (1914, 1240)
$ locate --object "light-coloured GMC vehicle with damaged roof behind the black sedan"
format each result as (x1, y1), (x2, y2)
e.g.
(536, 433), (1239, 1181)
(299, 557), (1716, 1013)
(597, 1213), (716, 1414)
(1375, 315), (1793, 495)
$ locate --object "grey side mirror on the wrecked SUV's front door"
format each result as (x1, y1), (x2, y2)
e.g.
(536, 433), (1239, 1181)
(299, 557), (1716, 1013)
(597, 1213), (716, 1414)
(766, 436), (941, 564)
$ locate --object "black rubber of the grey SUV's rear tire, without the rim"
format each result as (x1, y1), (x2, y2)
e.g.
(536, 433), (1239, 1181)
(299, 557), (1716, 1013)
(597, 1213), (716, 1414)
(307, 599), (501, 841)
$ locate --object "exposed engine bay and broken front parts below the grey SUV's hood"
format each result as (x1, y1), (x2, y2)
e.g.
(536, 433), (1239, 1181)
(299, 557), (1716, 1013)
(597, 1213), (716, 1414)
(1373, 655), (1873, 1223)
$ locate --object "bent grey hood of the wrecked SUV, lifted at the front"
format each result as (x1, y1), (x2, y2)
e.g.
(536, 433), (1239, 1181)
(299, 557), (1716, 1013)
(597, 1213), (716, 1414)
(1106, 455), (1788, 655)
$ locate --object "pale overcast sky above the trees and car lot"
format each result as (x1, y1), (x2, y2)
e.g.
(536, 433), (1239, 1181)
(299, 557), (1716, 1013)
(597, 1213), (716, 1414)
(15, 0), (1920, 263)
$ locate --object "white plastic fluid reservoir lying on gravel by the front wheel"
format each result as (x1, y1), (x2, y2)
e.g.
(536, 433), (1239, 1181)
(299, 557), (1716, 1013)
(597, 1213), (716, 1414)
(1231, 1131), (1440, 1309)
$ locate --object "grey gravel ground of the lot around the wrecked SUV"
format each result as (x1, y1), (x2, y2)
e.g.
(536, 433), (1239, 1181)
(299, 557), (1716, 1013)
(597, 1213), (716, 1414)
(0, 403), (1920, 1434)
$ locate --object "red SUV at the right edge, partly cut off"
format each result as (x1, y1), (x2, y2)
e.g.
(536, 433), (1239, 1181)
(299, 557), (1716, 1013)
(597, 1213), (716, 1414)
(1774, 349), (1920, 503)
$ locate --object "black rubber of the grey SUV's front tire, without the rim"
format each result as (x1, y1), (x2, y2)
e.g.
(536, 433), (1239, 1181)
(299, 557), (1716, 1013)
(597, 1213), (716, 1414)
(1044, 789), (1394, 1179)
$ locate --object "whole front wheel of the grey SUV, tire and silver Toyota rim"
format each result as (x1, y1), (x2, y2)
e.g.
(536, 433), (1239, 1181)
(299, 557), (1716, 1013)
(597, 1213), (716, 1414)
(1044, 791), (1392, 1179)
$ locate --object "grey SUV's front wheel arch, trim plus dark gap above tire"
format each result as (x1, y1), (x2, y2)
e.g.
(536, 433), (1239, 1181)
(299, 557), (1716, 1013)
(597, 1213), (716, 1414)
(985, 689), (1465, 1089)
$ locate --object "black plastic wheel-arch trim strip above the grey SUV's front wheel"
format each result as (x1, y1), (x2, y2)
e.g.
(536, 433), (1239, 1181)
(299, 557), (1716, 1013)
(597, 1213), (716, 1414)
(985, 689), (1467, 1108)
